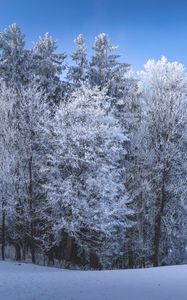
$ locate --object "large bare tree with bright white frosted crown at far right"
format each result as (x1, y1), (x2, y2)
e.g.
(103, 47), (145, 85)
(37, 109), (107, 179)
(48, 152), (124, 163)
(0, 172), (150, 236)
(129, 57), (187, 266)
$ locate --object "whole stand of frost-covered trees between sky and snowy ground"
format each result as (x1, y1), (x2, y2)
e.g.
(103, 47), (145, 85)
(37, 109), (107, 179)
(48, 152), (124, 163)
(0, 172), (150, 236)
(0, 24), (187, 269)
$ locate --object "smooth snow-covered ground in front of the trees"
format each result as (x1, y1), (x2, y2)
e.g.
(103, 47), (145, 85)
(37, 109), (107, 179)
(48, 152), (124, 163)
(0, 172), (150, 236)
(0, 262), (187, 300)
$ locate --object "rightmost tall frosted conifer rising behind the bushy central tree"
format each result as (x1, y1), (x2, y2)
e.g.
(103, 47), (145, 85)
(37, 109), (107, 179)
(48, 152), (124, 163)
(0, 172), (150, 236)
(88, 33), (140, 139)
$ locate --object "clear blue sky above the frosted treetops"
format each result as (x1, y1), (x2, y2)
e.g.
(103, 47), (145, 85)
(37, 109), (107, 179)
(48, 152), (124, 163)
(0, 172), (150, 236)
(0, 0), (187, 69)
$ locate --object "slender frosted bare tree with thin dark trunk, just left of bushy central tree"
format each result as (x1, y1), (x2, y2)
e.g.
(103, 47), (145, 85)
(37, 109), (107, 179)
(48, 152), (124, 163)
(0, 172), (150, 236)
(13, 86), (49, 262)
